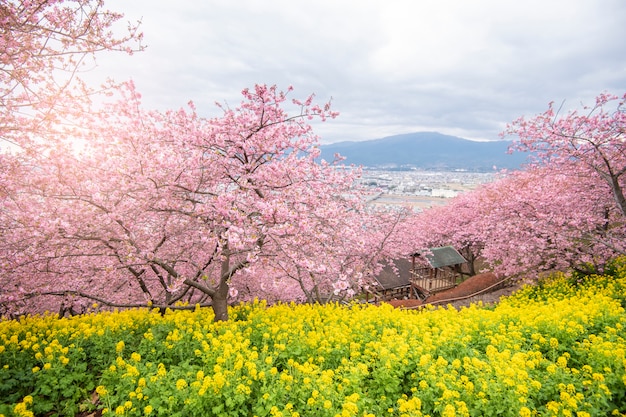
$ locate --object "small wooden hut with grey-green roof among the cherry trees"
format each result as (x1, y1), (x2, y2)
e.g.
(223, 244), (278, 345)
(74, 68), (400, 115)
(410, 246), (467, 294)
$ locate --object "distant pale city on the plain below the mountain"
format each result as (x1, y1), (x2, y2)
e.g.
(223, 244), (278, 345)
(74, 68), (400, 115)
(360, 169), (497, 211)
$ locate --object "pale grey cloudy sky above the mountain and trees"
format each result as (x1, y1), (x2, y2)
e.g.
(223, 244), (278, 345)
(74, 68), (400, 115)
(94, 0), (626, 143)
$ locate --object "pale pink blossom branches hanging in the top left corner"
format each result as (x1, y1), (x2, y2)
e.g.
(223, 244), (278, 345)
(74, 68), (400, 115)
(0, 0), (143, 146)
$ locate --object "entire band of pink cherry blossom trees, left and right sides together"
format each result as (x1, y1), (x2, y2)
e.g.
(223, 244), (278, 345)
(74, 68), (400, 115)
(0, 0), (626, 320)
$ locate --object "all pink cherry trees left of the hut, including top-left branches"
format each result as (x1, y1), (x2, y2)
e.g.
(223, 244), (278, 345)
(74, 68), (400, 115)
(0, 0), (414, 320)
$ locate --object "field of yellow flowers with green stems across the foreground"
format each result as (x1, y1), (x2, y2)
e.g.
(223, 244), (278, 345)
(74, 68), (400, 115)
(0, 260), (626, 417)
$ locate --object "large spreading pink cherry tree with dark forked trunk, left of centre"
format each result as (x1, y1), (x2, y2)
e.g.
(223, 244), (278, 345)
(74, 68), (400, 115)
(1, 85), (404, 320)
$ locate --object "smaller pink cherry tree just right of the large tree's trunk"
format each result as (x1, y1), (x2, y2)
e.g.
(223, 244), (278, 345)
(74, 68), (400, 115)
(232, 178), (363, 302)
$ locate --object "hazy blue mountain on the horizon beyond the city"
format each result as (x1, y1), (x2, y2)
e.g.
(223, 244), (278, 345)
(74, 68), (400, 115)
(321, 132), (526, 171)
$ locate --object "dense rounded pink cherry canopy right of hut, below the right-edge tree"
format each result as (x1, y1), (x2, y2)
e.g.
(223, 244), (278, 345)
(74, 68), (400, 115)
(413, 167), (626, 278)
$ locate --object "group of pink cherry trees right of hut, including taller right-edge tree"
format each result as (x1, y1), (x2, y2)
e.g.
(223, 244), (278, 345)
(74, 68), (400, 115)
(412, 94), (626, 277)
